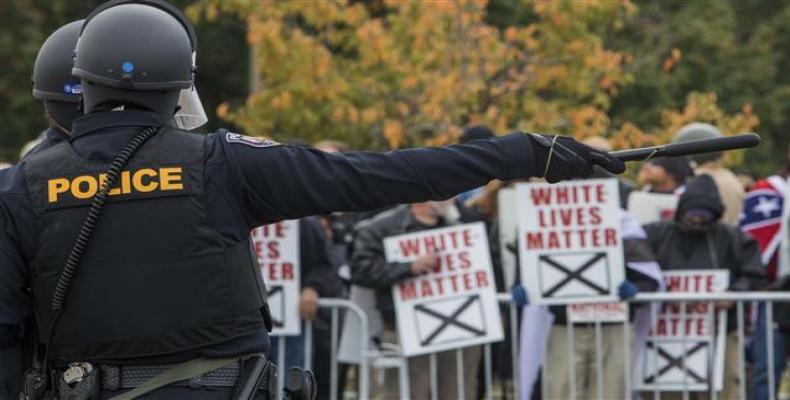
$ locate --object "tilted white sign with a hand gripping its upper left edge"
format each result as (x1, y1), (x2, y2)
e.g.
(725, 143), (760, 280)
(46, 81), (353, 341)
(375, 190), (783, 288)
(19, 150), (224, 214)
(384, 222), (503, 357)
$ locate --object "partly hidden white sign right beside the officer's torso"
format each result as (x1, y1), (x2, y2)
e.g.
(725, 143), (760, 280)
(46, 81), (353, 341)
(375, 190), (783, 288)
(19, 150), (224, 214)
(252, 220), (302, 336)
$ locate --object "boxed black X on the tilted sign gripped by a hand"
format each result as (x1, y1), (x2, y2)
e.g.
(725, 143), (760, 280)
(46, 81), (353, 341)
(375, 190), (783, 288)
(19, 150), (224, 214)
(414, 294), (486, 346)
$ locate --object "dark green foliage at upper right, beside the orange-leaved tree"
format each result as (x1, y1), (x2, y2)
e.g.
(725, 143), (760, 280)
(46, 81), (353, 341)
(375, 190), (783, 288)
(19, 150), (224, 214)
(607, 0), (790, 176)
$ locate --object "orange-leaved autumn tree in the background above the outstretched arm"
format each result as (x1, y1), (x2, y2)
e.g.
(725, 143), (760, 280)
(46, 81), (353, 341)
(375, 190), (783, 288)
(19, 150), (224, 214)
(192, 0), (635, 147)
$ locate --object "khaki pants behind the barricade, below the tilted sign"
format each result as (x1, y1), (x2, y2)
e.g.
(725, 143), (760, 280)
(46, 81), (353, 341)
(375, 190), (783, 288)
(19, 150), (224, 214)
(370, 329), (483, 400)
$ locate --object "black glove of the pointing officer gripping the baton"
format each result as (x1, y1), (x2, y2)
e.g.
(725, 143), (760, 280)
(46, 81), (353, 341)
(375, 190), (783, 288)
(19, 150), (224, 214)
(528, 133), (625, 183)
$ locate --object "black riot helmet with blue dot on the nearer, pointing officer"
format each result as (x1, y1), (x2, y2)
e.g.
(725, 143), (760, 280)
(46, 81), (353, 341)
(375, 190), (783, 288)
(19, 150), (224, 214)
(72, 0), (197, 121)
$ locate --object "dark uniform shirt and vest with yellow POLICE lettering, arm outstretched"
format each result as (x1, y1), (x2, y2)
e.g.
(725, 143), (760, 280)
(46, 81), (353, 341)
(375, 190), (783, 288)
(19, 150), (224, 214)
(0, 111), (536, 396)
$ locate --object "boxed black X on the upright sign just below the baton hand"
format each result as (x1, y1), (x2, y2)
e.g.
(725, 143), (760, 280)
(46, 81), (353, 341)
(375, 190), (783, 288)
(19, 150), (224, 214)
(538, 252), (610, 298)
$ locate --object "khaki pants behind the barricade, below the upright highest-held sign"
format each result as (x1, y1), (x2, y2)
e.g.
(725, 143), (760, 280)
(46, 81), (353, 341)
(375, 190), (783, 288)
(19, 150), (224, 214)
(544, 323), (630, 399)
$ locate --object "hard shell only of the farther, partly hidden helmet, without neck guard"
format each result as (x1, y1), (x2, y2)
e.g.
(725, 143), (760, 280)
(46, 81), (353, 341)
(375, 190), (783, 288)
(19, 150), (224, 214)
(32, 20), (83, 103)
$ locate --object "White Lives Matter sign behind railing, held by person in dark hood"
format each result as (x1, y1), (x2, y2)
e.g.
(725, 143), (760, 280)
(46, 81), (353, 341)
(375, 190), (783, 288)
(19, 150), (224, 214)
(636, 270), (729, 391)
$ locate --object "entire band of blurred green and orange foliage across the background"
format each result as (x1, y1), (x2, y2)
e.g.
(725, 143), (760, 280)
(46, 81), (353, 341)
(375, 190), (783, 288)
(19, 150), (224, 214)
(0, 0), (790, 175)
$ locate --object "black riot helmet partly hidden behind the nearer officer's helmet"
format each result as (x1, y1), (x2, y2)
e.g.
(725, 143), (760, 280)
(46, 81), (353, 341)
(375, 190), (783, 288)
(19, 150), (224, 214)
(32, 20), (83, 132)
